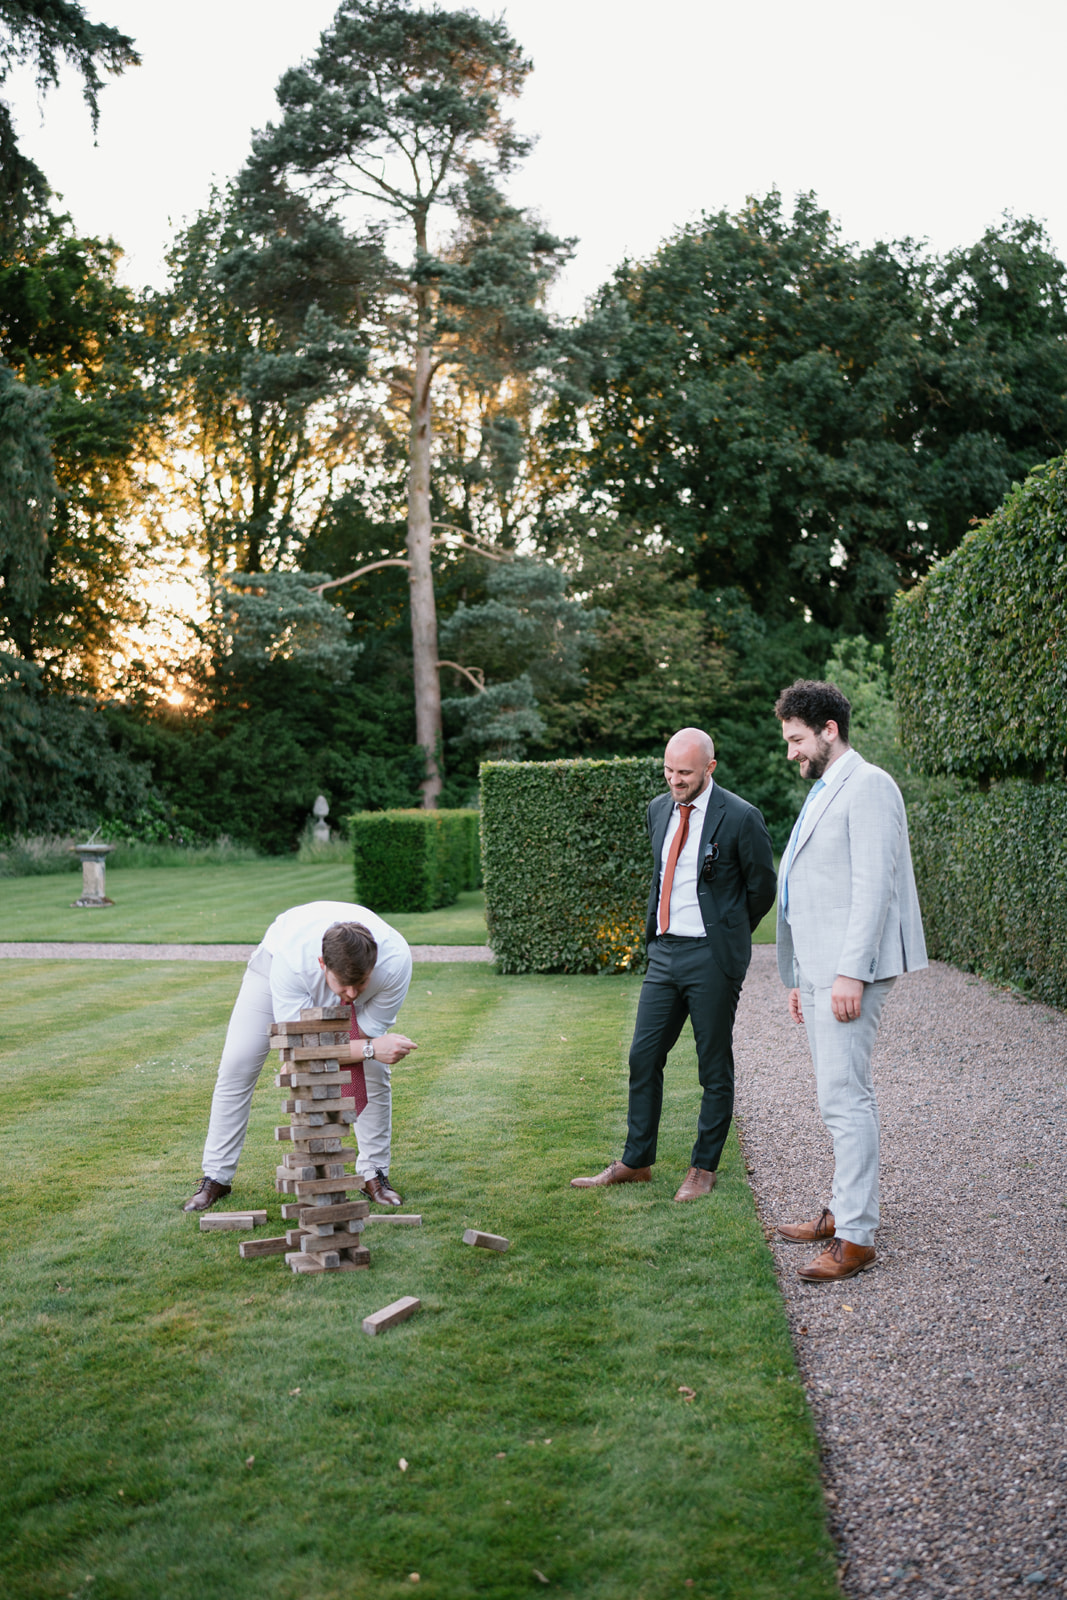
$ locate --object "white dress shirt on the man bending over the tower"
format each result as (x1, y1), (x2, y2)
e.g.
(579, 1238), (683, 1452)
(262, 901), (411, 1038)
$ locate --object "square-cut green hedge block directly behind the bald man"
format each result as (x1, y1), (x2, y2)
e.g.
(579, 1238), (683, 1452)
(482, 757), (665, 973)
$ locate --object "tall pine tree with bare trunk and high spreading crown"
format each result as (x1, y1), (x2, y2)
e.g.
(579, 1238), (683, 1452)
(242, 0), (566, 806)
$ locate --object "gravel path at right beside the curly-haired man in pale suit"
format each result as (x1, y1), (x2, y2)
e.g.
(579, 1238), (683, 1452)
(734, 946), (1067, 1600)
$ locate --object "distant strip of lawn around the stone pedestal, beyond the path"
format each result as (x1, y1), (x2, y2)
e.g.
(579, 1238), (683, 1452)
(0, 861), (486, 944)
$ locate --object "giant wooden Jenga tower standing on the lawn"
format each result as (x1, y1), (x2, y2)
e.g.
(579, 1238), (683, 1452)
(270, 1006), (371, 1272)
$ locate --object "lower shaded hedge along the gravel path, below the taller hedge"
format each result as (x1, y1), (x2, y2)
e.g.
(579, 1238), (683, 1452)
(910, 779), (1067, 1006)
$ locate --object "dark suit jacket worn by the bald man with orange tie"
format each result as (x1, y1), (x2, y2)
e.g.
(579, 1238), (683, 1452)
(645, 784), (777, 982)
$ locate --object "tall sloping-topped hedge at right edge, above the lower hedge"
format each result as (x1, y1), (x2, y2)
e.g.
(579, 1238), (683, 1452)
(891, 456), (1067, 779)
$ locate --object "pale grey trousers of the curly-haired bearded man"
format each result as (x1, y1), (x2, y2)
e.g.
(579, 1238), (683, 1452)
(797, 971), (896, 1245)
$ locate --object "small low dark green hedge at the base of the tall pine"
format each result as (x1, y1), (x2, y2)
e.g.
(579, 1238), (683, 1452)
(347, 811), (482, 914)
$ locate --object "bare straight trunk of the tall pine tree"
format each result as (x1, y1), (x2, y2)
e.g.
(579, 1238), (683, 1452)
(408, 290), (442, 811)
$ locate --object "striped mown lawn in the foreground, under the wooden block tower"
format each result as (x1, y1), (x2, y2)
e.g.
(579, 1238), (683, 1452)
(0, 962), (838, 1600)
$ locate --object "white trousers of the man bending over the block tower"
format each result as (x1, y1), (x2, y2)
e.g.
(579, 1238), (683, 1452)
(203, 949), (392, 1184)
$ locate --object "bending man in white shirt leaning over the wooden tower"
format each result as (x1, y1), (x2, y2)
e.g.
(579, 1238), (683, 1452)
(182, 901), (416, 1211)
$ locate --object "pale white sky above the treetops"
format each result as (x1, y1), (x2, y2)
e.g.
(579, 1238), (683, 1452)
(0, 0), (1067, 314)
